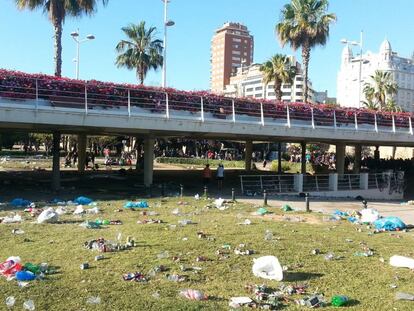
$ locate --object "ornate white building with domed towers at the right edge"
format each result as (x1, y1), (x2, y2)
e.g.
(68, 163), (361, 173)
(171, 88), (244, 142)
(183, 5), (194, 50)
(337, 40), (414, 112)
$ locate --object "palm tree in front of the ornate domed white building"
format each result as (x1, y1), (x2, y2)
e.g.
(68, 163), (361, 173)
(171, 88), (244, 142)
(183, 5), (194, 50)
(364, 70), (398, 110)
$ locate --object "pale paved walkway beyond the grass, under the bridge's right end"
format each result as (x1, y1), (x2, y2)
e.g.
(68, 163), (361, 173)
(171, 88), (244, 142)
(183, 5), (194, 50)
(239, 198), (414, 224)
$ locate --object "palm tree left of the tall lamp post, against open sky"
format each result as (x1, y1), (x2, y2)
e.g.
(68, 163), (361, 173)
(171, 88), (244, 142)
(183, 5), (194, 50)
(116, 22), (163, 84)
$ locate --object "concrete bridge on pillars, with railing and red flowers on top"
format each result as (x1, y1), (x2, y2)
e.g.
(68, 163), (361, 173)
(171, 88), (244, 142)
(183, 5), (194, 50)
(0, 70), (414, 188)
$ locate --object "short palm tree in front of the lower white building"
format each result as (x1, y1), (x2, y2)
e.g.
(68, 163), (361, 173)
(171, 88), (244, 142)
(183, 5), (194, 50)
(260, 54), (296, 101)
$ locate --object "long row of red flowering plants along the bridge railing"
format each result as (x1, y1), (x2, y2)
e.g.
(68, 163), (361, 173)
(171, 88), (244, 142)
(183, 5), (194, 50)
(0, 69), (411, 128)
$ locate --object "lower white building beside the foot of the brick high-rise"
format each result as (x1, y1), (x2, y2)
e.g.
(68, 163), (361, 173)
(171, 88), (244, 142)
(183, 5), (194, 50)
(224, 60), (313, 102)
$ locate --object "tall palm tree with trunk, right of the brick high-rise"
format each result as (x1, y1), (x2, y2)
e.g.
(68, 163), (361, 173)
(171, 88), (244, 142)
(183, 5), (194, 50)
(276, 0), (336, 102)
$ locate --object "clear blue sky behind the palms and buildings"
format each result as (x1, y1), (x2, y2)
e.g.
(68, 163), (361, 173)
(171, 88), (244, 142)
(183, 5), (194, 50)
(0, 0), (414, 96)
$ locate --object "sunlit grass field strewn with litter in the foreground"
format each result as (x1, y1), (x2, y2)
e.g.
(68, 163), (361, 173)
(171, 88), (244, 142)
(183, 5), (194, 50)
(0, 197), (414, 310)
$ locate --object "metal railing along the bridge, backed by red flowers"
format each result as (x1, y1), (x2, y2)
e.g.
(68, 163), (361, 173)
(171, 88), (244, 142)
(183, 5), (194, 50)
(0, 70), (413, 135)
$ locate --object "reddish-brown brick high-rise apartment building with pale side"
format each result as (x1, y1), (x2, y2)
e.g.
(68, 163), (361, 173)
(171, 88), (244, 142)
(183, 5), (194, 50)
(210, 23), (254, 94)
